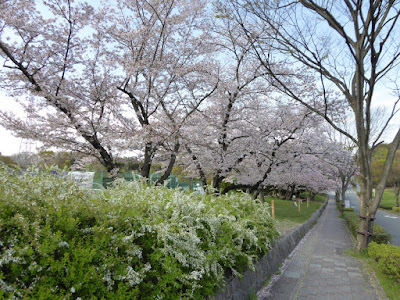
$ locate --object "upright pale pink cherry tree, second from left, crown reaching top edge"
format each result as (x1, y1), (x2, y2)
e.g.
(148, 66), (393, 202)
(96, 0), (218, 183)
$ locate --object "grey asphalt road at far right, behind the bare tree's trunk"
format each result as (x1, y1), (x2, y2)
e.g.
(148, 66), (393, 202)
(334, 190), (400, 246)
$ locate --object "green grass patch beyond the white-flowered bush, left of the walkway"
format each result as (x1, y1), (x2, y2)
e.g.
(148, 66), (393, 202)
(265, 197), (322, 234)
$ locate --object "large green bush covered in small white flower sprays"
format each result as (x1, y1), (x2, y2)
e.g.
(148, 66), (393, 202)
(0, 166), (277, 299)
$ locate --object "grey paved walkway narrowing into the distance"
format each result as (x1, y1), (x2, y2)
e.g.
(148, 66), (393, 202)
(257, 199), (387, 300)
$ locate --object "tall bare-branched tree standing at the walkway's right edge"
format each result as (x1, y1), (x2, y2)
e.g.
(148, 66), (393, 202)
(230, 0), (400, 249)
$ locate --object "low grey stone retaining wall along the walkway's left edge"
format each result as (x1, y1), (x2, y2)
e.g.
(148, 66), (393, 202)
(209, 198), (329, 300)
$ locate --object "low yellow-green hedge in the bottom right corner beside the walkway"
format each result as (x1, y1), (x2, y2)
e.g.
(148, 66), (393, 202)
(368, 242), (400, 283)
